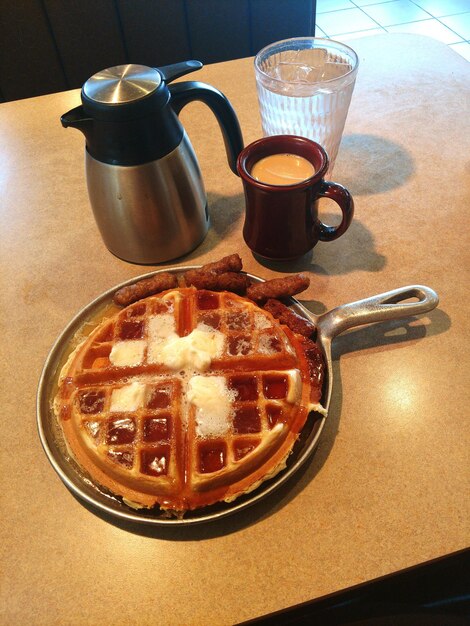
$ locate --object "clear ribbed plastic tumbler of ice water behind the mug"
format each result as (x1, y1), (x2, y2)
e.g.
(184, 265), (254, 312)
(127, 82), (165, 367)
(255, 37), (359, 174)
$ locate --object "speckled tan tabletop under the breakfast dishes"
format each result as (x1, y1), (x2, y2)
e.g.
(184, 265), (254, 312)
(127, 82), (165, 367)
(0, 35), (470, 626)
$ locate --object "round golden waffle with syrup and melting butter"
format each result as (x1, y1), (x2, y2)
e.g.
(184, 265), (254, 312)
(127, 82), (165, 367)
(54, 287), (323, 515)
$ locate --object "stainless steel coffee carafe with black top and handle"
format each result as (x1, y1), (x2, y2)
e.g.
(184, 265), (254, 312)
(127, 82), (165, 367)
(61, 61), (243, 264)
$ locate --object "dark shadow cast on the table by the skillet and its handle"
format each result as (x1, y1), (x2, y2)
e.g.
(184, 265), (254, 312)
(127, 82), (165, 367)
(80, 309), (451, 541)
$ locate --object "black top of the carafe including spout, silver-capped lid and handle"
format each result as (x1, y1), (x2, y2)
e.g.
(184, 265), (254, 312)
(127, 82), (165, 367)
(61, 60), (243, 168)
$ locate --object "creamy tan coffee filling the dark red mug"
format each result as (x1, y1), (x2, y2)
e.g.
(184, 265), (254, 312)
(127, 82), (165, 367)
(251, 153), (315, 185)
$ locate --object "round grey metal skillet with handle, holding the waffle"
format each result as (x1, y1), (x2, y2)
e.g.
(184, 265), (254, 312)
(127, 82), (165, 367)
(37, 266), (439, 526)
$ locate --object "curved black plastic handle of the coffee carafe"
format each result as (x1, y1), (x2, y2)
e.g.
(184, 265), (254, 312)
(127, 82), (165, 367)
(168, 81), (243, 176)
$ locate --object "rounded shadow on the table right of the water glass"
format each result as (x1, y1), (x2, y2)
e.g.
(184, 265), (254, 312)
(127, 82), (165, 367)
(332, 134), (415, 197)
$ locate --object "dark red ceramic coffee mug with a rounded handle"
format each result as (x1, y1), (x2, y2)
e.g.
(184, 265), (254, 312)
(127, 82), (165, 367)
(237, 135), (354, 261)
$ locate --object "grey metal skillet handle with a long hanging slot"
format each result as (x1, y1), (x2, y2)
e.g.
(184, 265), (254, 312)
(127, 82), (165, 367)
(317, 285), (439, 339)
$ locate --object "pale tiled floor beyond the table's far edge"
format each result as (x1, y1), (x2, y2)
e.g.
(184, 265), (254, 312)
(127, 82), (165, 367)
(315, 0), (470, 61)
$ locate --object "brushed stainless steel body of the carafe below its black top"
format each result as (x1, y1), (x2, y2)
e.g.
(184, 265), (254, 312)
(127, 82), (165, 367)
(86, 132), (209, 264)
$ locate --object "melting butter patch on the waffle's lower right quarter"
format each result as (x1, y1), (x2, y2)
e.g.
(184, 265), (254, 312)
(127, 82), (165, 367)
(187, 376), (235, 437)
